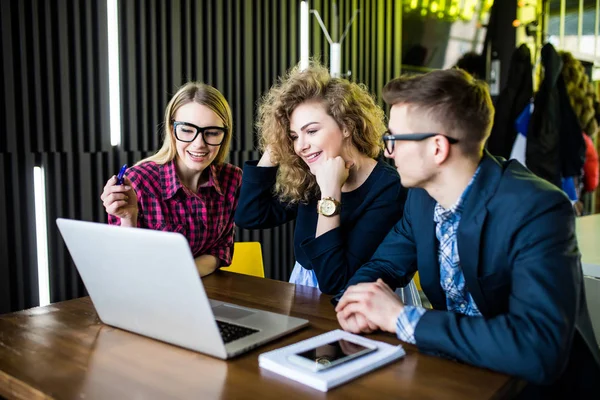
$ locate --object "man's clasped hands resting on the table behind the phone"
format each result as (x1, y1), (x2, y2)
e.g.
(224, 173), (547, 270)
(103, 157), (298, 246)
(335, 279), (404, 333)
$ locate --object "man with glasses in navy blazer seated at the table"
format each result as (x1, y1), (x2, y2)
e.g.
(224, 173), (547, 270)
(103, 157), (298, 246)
(336, 69), (600, 398)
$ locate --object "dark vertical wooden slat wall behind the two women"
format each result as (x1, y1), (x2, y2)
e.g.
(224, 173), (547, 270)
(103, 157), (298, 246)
(0, 0), (401, 313)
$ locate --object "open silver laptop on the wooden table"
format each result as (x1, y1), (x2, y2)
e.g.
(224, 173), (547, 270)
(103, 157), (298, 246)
(56, 218), (308, 359)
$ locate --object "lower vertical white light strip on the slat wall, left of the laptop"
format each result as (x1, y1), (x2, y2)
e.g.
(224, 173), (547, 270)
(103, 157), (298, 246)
(33, 167), (50, 306)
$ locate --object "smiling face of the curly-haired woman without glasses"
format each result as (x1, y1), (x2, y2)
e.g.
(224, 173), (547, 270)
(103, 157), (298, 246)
(290, 101), (345, 174)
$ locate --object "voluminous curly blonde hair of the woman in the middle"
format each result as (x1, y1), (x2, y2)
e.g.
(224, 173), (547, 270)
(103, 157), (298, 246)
(256, 61), (385, 203)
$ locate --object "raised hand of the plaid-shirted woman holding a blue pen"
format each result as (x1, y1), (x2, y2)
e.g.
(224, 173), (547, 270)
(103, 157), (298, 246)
(100, 176), (138, 227)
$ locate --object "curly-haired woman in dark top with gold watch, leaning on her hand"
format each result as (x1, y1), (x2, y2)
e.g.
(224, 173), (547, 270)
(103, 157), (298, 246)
(235, 64), (406, 294)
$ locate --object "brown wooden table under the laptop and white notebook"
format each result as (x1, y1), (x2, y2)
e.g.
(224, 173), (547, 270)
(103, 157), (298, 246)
(0, 271), (523, 400)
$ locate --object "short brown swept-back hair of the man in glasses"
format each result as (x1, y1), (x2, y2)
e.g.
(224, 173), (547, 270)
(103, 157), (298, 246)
(383, 68), (494, 156)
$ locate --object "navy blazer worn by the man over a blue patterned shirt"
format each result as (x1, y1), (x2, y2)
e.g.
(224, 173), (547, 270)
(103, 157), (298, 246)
(348, 152), (600, 397)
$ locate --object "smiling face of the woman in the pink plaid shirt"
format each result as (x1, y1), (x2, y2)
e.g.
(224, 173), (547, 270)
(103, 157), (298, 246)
(174, 102), (224, 176)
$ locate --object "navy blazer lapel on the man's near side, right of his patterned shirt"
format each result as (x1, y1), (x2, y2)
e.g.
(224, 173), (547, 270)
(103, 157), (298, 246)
(458, 151), (502, 315)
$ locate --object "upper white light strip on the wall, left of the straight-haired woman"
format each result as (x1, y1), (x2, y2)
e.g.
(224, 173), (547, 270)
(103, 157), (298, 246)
(106, 0), (121, 146)
